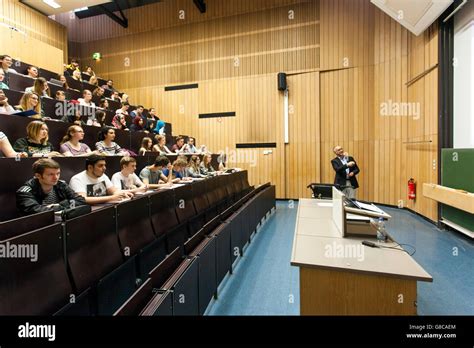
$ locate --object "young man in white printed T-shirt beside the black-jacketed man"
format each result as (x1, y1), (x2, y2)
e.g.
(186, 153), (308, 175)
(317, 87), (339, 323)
(69, 155), (133, 205)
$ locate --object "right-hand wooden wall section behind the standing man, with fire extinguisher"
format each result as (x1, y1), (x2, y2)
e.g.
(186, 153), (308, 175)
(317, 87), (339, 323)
(321, 0), (438, 220)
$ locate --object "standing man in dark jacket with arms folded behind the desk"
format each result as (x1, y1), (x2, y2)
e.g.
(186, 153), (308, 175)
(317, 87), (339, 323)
(331, 145), (360, 198)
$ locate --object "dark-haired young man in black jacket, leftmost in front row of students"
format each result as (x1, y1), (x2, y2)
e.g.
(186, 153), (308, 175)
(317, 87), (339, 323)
(16, 158), (87, 214)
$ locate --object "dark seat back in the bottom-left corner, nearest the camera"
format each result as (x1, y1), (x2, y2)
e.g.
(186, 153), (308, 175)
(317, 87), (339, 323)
(0, 223), (72, 315)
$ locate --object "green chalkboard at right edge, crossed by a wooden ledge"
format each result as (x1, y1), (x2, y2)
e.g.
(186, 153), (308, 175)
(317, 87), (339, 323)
(441, 149), (474, 232)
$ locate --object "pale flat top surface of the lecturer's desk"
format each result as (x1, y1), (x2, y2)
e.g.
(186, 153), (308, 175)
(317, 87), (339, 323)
(291, 199), (433, 282)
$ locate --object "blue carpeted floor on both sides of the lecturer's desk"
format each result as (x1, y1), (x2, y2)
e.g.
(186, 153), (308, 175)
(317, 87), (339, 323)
(207, 201), (474, 315)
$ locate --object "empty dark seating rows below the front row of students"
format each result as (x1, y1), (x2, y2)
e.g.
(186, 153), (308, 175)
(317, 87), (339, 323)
(0, 172), (275, 315)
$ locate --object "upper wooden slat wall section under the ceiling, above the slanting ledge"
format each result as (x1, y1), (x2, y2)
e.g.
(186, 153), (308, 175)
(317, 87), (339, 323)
(58, 0), (319, 89)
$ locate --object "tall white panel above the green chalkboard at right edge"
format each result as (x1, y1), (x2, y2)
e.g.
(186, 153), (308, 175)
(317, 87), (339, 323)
(453, 0), (474, 148)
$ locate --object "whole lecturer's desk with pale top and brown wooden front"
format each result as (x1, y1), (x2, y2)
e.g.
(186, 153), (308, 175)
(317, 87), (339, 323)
(291, 199), (433, 315)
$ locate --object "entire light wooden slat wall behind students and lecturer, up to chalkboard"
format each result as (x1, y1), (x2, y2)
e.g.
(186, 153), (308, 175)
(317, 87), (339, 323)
(53, 0), (438, 220)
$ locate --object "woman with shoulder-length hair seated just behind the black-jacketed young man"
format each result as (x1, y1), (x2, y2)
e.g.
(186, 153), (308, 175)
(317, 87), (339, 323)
(13, 121), (61, 157)
